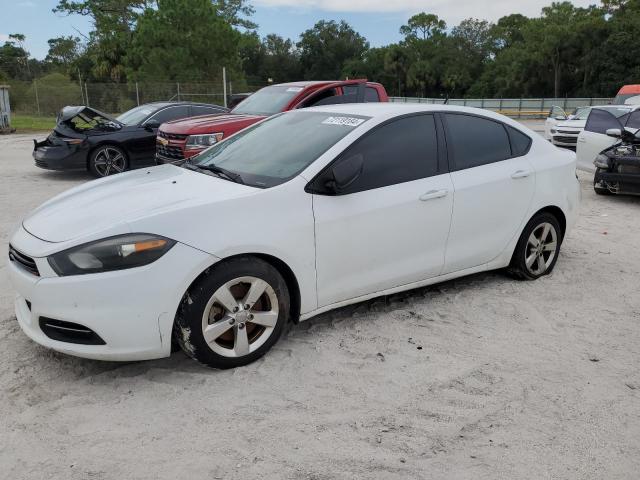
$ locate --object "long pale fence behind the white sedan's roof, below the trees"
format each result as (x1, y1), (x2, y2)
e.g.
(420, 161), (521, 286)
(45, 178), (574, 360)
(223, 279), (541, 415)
(389, 97), (613, 118)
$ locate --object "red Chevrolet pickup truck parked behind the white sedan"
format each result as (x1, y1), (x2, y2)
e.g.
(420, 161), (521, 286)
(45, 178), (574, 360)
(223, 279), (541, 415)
(156, 80), (389, 164)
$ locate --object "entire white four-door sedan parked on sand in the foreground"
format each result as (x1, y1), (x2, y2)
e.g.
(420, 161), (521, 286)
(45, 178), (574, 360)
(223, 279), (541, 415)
(8, 104), (579, 368)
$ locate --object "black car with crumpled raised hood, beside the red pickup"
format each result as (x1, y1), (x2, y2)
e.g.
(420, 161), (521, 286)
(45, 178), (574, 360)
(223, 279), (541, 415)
(33, 102), (228, 177)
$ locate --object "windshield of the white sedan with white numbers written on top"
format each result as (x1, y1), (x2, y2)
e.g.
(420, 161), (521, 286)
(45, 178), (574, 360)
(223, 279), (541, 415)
(193, 111), (370, 188)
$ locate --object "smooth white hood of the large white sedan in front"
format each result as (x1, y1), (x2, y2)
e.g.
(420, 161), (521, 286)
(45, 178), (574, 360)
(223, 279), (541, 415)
(23, 165), (260, 243)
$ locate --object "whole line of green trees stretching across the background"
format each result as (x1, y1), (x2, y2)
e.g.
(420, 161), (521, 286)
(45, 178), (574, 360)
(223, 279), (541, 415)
(6, 0), (640, 100)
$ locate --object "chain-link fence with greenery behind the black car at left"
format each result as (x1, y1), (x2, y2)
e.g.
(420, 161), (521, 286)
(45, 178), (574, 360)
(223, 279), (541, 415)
(9, 76), (265, 116)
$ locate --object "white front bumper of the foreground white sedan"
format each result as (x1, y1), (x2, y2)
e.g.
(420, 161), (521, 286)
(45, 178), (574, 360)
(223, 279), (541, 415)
(7, 230), (217, 361)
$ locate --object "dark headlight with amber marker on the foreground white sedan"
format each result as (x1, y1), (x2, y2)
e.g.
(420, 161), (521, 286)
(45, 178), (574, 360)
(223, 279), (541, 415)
(48, 233), (176, 276)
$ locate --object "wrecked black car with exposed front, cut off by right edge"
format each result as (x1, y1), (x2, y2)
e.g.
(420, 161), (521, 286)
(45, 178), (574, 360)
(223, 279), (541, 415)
(593, 128), (640, 195)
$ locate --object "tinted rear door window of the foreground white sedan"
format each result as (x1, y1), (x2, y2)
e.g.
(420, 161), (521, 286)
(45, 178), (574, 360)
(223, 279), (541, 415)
(445, 113), (512, 170)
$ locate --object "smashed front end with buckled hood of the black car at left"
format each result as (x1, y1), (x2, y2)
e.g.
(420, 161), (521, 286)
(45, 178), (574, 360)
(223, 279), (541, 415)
(33, 106), (123, 170)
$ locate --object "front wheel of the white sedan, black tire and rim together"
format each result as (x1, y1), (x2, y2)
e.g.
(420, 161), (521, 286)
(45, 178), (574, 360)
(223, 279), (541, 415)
(174, 257), (291, 369)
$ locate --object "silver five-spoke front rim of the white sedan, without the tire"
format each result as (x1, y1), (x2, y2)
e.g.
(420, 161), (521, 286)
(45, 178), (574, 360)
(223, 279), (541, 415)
(202, 277), (279, 357)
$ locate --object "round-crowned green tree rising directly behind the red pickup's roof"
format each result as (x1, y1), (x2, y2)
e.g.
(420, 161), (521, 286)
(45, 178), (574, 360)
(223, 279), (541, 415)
(297, 20), (369, 79)
